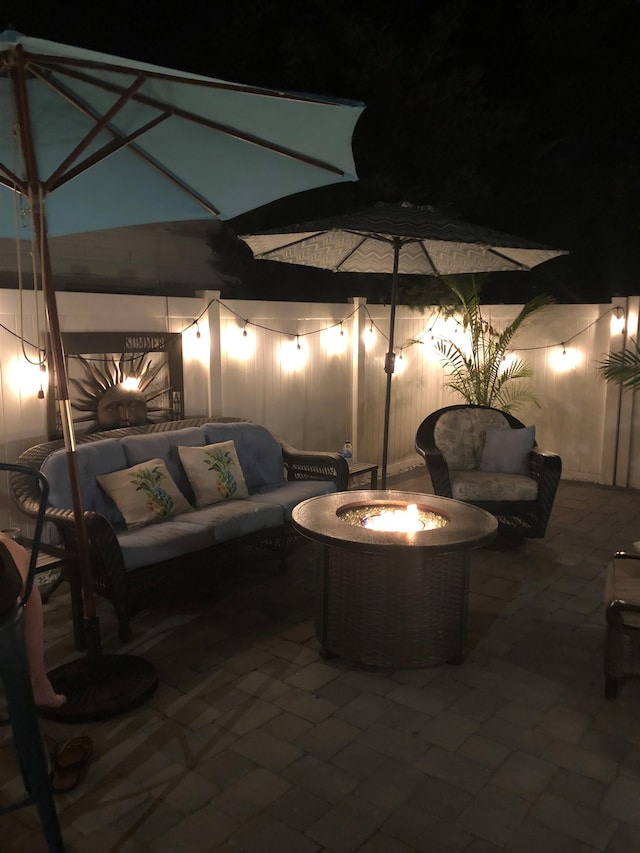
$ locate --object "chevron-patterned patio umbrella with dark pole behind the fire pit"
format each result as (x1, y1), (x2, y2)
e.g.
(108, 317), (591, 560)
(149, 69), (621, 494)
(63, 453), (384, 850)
(241, 202), (566, 489)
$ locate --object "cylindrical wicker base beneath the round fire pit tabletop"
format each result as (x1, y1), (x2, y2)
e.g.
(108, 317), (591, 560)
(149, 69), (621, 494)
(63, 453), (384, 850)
(316, 546), (469, 669)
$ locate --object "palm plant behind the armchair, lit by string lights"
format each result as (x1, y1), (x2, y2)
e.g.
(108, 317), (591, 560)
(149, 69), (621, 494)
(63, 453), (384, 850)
(436, 277), (554, 412)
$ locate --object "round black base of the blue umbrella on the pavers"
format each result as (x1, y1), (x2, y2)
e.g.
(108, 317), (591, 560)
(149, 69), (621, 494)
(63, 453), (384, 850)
(38, 655), (158, 723)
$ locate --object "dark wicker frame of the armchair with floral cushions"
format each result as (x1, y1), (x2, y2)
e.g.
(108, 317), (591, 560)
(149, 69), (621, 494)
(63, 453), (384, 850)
(416, 404), (562, 538)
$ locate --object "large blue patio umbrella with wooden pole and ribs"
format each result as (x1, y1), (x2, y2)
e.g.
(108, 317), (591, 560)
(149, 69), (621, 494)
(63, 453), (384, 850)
(0, 31), (364, 716)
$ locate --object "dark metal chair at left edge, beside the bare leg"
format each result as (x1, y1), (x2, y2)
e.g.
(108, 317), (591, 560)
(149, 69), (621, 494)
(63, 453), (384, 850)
(0, 463), (65, 853)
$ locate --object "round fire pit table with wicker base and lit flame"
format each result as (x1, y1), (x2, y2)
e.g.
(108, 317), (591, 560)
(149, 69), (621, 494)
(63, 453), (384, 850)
(292, 490), (498, 669)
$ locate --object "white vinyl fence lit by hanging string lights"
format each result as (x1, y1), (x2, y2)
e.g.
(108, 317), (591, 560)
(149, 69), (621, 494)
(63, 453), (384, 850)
(0, 290), (640, 527)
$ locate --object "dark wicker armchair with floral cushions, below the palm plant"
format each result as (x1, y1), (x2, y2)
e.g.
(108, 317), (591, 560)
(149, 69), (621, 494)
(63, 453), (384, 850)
(416, 404), (562, 538)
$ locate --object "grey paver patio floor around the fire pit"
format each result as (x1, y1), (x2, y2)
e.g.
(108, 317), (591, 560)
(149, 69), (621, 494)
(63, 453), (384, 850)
(0, 469), (640, 853)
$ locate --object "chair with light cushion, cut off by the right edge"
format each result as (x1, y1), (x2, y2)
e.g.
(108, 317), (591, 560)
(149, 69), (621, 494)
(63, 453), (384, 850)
(604, 551), (640, 699)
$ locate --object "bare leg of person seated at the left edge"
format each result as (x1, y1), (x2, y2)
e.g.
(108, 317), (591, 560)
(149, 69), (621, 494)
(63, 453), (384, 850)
(0, 534), (65, 708)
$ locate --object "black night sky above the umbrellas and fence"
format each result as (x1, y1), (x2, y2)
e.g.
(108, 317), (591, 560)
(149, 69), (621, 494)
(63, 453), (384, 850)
(5, 0), (640, 302)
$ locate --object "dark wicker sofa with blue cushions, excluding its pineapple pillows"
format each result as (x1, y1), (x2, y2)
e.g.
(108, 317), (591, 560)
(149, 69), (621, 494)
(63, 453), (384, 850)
(11, 418), (348, 641)
